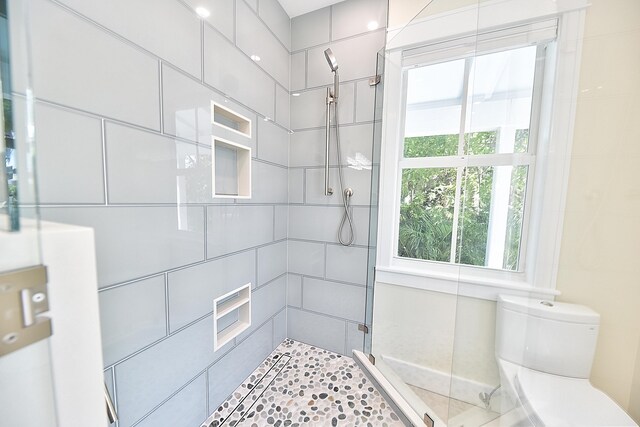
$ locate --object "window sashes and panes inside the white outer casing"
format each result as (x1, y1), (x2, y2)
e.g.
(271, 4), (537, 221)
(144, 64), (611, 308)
(396, 44), (544, 271)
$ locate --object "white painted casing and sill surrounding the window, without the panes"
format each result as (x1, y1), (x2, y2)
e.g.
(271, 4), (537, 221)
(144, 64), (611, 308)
(376, 0), (588, 300)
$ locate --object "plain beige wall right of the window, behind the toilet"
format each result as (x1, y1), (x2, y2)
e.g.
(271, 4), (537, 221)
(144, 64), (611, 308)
(558, 0), (640, 421)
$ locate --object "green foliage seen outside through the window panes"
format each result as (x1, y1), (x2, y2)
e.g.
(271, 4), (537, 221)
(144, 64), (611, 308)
(398, 129), (529, 270)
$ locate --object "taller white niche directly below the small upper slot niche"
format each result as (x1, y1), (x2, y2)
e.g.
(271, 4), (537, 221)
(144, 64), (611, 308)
(211, 137), (251, 199)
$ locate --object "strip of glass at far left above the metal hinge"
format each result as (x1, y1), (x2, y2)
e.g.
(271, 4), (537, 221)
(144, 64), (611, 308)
(0, 0), (41, 271)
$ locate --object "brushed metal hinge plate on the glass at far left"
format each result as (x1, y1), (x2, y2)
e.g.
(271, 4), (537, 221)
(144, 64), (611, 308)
(0, 265), (52, 356)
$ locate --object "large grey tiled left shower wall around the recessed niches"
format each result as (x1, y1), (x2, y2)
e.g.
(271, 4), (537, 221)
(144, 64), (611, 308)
(25, 0), (291, 427)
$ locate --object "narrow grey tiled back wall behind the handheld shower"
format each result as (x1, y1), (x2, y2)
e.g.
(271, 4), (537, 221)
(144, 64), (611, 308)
(287, 0), (387, 362)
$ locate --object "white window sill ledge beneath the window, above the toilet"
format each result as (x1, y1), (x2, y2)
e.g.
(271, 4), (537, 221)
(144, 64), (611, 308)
(375, 266), (560, 301)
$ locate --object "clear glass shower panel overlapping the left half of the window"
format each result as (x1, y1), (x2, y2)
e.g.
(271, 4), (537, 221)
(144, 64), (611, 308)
(365, 0), (476, 427)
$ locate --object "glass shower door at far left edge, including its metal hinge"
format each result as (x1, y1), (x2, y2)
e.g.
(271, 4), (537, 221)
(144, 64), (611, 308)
(0, 0), (57, 427)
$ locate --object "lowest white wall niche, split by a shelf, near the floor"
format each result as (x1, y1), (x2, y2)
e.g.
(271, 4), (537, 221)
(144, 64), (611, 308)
(213, 283), (251, 351)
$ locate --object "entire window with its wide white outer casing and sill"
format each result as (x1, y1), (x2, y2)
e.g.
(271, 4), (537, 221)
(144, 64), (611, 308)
(376, 0), (587, 292)
